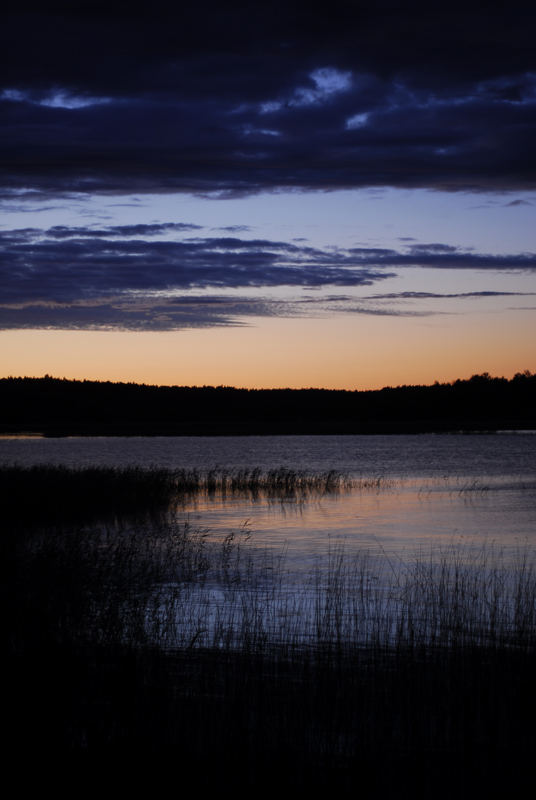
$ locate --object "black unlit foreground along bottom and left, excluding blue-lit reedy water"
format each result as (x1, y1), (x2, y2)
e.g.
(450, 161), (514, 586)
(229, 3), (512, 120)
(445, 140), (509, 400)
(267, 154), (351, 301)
(2, 468), (536, 798)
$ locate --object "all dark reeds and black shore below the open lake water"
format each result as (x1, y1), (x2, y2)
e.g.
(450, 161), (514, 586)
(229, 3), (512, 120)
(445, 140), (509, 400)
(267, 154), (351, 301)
(4, 467), (536, 797)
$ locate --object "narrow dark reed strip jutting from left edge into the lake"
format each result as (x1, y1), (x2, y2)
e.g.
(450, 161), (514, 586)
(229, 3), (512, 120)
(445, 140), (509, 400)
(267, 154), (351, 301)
(0, 464), (356, 524)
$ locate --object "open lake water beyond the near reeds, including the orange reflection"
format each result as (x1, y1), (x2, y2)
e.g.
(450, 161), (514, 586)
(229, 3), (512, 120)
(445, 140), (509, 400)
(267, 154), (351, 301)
(0, 432), (536, 566)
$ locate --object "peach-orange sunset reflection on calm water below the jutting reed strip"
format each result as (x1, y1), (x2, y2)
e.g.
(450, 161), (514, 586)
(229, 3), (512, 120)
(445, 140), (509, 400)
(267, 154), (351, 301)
(180, 480), (536, 567)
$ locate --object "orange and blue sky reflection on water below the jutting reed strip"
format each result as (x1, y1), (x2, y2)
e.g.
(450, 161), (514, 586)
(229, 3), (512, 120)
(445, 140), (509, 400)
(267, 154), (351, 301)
(163, 479), (536, 646)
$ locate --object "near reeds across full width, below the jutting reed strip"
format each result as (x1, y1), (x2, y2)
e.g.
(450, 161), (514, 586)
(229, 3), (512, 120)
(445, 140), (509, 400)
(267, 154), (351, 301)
(8, 500), (536, 658)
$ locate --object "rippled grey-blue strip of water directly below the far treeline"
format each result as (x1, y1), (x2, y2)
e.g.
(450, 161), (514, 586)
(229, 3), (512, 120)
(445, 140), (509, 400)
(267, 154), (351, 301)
(0, 434), (536, 478)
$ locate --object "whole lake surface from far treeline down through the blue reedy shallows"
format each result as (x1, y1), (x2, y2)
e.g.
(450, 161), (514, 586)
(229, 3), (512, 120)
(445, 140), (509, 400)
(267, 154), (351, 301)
(4, 432), (536, 647)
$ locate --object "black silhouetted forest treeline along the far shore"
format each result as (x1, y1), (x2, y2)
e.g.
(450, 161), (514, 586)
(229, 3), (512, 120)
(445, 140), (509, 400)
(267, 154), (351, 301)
(0, 371), (536, 435)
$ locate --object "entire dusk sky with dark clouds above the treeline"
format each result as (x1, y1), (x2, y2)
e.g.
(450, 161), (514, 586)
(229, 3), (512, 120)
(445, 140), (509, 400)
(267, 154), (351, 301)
(0, 0), (536, 389)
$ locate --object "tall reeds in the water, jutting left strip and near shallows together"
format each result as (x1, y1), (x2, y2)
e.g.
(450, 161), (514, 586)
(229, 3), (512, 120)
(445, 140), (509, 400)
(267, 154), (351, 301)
(5, 466), (536, 653)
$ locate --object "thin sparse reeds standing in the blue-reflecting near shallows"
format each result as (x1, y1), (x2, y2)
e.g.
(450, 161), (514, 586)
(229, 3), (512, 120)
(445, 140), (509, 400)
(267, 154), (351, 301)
(140, 534), (536, 659)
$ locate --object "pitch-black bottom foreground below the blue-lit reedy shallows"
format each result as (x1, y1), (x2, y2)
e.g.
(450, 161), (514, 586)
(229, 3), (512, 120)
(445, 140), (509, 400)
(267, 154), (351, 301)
(9, 644), (536, 797)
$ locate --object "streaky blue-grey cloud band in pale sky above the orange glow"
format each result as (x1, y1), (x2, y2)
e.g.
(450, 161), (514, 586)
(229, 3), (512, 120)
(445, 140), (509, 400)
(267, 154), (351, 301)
(0, 223), (536, 330)
